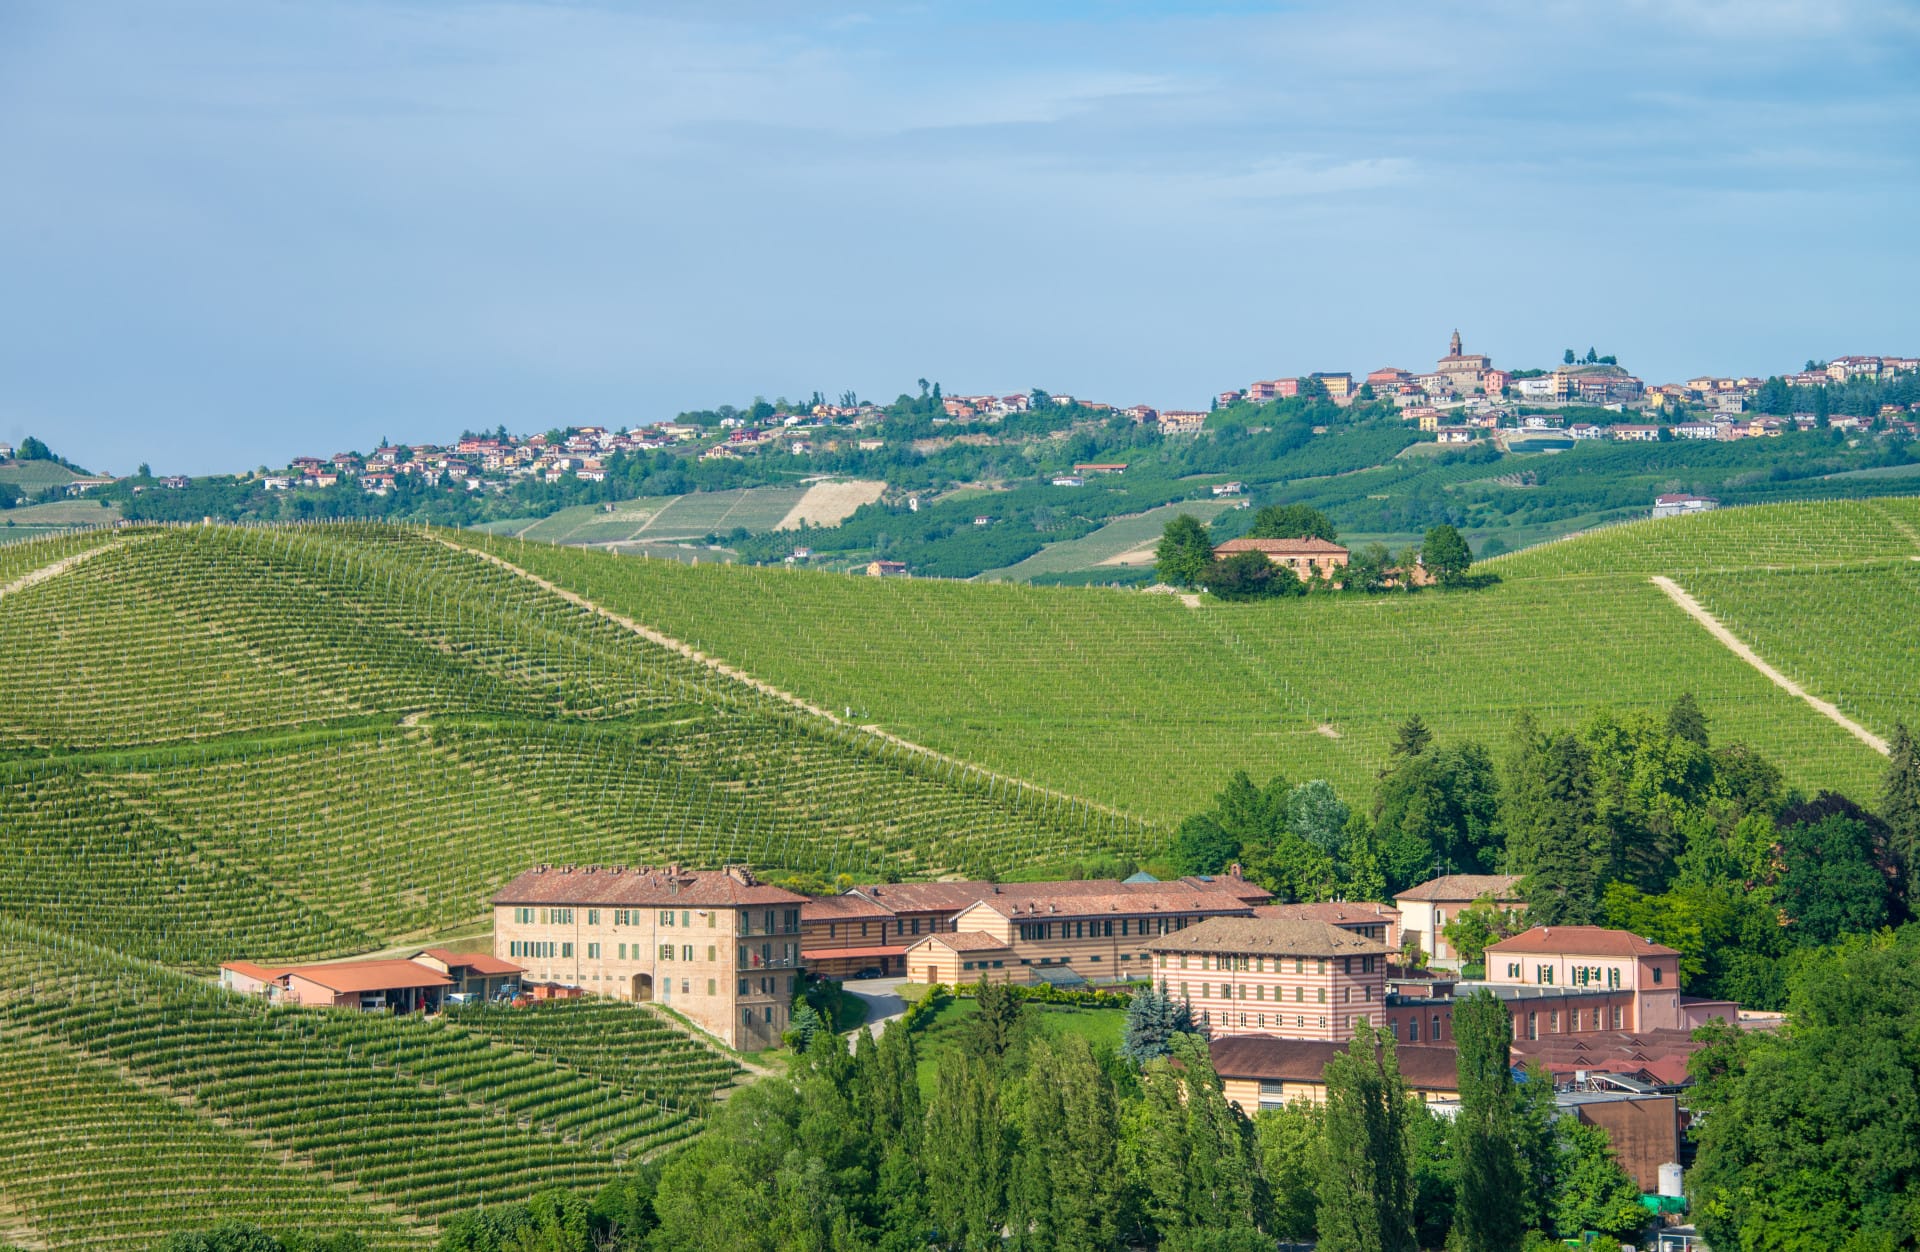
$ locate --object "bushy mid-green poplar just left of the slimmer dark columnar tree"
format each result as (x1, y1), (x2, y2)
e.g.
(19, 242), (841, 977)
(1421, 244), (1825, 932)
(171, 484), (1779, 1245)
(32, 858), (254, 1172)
(1313, 1020), (1415, 1252)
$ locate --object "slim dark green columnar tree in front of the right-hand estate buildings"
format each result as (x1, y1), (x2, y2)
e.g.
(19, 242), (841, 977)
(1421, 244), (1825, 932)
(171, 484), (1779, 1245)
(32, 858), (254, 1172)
(1448, 991), (1526, 1252)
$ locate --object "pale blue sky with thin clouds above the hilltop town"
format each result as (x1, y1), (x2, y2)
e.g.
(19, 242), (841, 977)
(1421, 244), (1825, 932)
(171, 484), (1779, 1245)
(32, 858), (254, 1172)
(0, 0), (1920, 472)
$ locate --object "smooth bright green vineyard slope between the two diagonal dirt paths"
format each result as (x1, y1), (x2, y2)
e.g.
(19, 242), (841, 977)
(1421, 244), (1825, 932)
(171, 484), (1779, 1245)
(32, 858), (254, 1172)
(487, 499), (1920, 822)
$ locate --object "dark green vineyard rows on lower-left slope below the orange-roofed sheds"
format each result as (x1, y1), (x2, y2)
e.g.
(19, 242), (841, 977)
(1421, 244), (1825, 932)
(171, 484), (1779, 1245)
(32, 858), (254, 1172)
(0, 922), (737, 1246)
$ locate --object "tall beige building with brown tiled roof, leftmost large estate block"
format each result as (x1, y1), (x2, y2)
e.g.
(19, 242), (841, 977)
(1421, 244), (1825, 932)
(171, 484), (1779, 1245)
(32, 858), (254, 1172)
(493, 866), (806, 1050)
